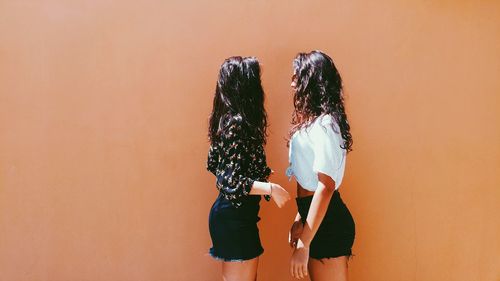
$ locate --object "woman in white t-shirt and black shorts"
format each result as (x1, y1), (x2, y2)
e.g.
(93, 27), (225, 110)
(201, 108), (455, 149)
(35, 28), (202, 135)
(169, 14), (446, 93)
(287, 51), (355, 281)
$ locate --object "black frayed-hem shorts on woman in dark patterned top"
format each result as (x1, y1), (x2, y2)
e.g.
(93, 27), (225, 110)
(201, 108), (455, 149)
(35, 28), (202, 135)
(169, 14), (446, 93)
(208, 193), (264, 261)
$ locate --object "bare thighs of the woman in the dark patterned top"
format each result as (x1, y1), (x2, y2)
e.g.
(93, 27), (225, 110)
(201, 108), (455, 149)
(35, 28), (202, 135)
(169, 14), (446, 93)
(222, 257), (259, 281)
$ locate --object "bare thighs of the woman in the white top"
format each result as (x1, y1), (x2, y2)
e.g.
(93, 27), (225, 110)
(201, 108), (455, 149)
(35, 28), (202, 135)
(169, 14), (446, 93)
(309, 256), (348, 281)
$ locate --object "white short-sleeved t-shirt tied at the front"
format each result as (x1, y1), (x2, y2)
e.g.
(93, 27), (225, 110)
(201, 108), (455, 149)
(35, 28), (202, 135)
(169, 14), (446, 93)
(286, 115), (347, 191)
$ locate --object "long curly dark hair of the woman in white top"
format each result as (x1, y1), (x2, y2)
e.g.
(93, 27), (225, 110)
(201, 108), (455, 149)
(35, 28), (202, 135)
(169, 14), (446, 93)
(289, 51), (353, 152)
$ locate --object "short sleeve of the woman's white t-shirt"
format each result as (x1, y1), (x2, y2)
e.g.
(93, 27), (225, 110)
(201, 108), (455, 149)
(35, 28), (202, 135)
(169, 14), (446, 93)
(311, 122), (344, 189)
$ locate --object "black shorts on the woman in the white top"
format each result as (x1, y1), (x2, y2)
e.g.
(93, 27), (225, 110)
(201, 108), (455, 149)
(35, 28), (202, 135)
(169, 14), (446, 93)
(296, 191), (355, 259)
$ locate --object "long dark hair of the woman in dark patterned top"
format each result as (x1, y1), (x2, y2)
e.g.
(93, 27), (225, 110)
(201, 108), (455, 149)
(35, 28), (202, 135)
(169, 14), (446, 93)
(208, 56), (267, 144)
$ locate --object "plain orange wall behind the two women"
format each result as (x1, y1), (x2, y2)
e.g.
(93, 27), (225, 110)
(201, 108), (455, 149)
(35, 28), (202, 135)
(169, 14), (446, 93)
(0, 0), (500, 281)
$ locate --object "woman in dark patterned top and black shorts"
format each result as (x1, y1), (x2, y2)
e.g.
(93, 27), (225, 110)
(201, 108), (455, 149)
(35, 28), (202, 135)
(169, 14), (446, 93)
(207, 57), (290, 281)
